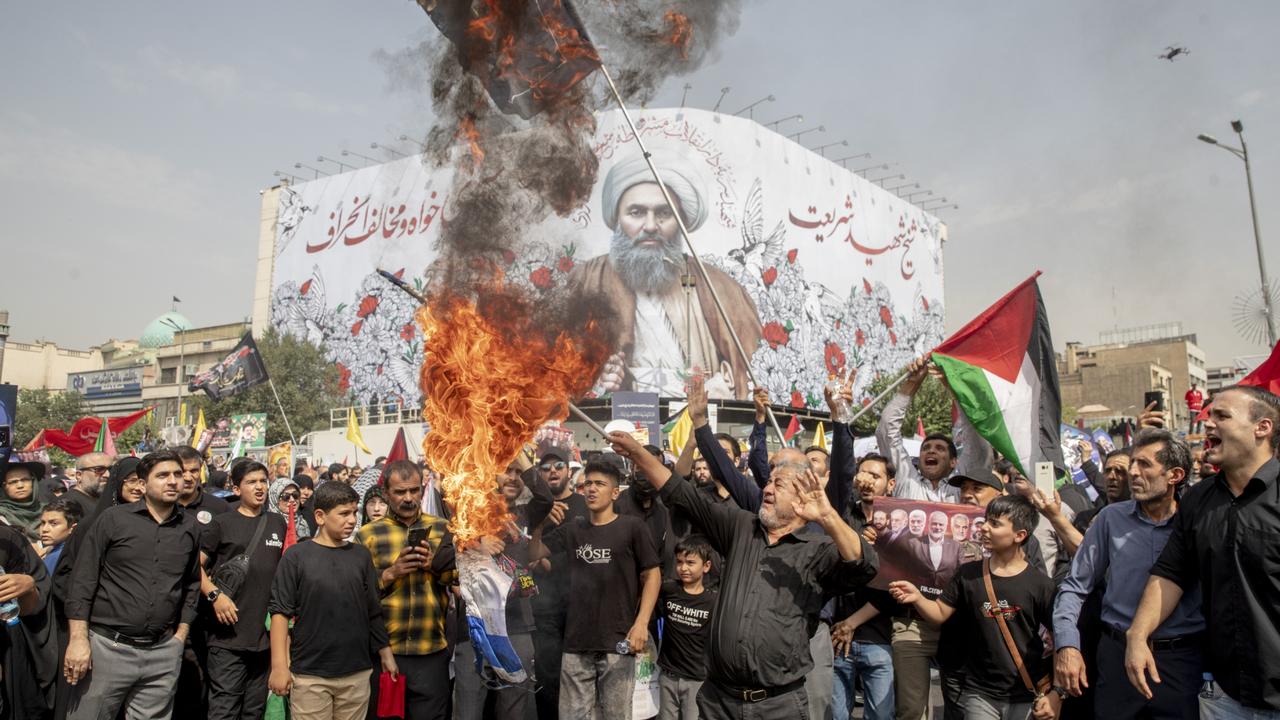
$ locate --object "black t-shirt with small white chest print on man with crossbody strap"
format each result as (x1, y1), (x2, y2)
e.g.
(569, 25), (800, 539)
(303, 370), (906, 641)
(200, 510), (285, 651)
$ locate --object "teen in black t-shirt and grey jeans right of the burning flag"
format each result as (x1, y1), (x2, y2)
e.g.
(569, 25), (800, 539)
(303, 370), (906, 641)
(529, 462), (662, 720)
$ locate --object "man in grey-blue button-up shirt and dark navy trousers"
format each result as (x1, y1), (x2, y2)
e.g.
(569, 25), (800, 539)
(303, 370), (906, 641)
(1053, 429), (1204, 720)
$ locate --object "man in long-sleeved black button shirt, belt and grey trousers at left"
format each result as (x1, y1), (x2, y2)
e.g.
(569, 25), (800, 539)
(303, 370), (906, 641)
(63, 451), (200, 720)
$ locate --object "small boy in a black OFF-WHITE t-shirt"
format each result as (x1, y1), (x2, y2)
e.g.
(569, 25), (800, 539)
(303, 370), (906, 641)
(658, 536), (716, 720)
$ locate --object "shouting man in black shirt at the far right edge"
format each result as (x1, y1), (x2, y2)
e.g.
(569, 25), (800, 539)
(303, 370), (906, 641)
(1125, 386), (1280, 719)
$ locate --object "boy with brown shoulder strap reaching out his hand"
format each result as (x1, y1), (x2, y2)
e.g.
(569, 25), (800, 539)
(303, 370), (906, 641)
(888, 496), (1062, 720)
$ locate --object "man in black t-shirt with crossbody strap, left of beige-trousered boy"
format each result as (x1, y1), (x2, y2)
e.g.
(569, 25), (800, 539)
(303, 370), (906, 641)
(200, 461), (285, 720)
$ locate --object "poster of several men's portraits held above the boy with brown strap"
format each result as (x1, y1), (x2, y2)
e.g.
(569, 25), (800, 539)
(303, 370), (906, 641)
(870, 497), (986, 598)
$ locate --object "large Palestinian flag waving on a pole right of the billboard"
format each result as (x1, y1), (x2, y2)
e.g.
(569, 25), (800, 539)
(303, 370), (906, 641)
(933, 272), (1065, 478)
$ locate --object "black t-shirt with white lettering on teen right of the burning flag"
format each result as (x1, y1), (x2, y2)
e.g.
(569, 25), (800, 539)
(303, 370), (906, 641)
(545, 515), (660, 652)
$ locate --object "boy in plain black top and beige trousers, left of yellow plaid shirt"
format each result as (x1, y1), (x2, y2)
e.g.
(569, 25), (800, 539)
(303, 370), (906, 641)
(268, 483), (399, 720)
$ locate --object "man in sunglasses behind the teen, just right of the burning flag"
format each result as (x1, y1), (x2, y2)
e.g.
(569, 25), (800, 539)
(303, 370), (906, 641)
(530, 447), (589, 720)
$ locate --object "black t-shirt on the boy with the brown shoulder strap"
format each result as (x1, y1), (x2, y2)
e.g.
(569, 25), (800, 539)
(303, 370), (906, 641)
(938, 562), (1056, 702)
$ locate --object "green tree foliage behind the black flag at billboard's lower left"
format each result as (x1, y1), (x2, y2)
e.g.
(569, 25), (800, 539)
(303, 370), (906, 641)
(187, 328), (342, 445)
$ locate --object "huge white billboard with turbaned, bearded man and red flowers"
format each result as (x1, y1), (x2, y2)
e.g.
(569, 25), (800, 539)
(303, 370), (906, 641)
(271, 109), (946, 407)
